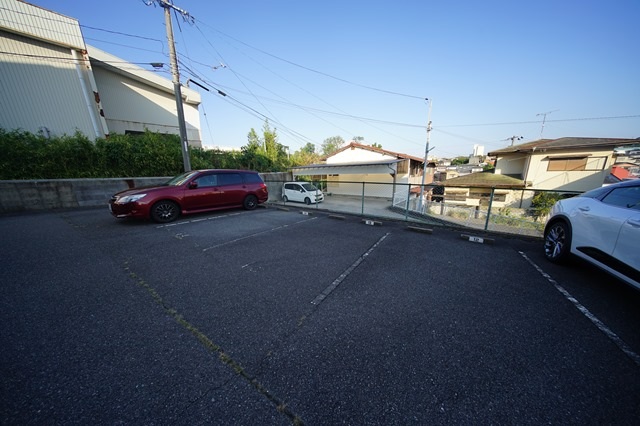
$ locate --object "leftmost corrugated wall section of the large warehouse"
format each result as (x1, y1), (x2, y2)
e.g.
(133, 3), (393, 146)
(0, 30), (95, 136)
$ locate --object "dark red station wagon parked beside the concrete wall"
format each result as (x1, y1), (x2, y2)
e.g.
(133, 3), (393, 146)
(109, 170), (269, 223)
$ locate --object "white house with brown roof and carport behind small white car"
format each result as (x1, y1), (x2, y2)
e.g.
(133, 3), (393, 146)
(291, 142), (434, 198)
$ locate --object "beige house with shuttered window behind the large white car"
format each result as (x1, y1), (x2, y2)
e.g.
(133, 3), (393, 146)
(489, 138), (638, 192)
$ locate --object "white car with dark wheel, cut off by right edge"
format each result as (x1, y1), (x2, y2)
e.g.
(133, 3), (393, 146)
(544, 179), (640, 289)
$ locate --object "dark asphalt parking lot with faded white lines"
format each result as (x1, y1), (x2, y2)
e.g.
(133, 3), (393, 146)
(0, 207), (640, 425)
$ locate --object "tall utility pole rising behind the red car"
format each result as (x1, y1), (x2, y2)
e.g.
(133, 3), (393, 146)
(146, 0), (192, 172)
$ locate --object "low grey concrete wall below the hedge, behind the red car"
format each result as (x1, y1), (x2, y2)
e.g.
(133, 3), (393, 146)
(0, 172), (291, 213)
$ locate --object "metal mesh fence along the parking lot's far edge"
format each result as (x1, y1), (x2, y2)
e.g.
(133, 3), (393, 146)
(270, 181), (577, 237)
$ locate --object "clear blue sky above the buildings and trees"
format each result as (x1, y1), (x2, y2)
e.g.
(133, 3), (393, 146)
(30, 0), (640, 157)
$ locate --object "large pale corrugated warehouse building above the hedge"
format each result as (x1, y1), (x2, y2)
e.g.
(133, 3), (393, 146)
(0, 0), (202, 147)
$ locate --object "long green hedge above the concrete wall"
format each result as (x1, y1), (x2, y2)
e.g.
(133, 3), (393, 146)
(0, 129), (279, 180)
